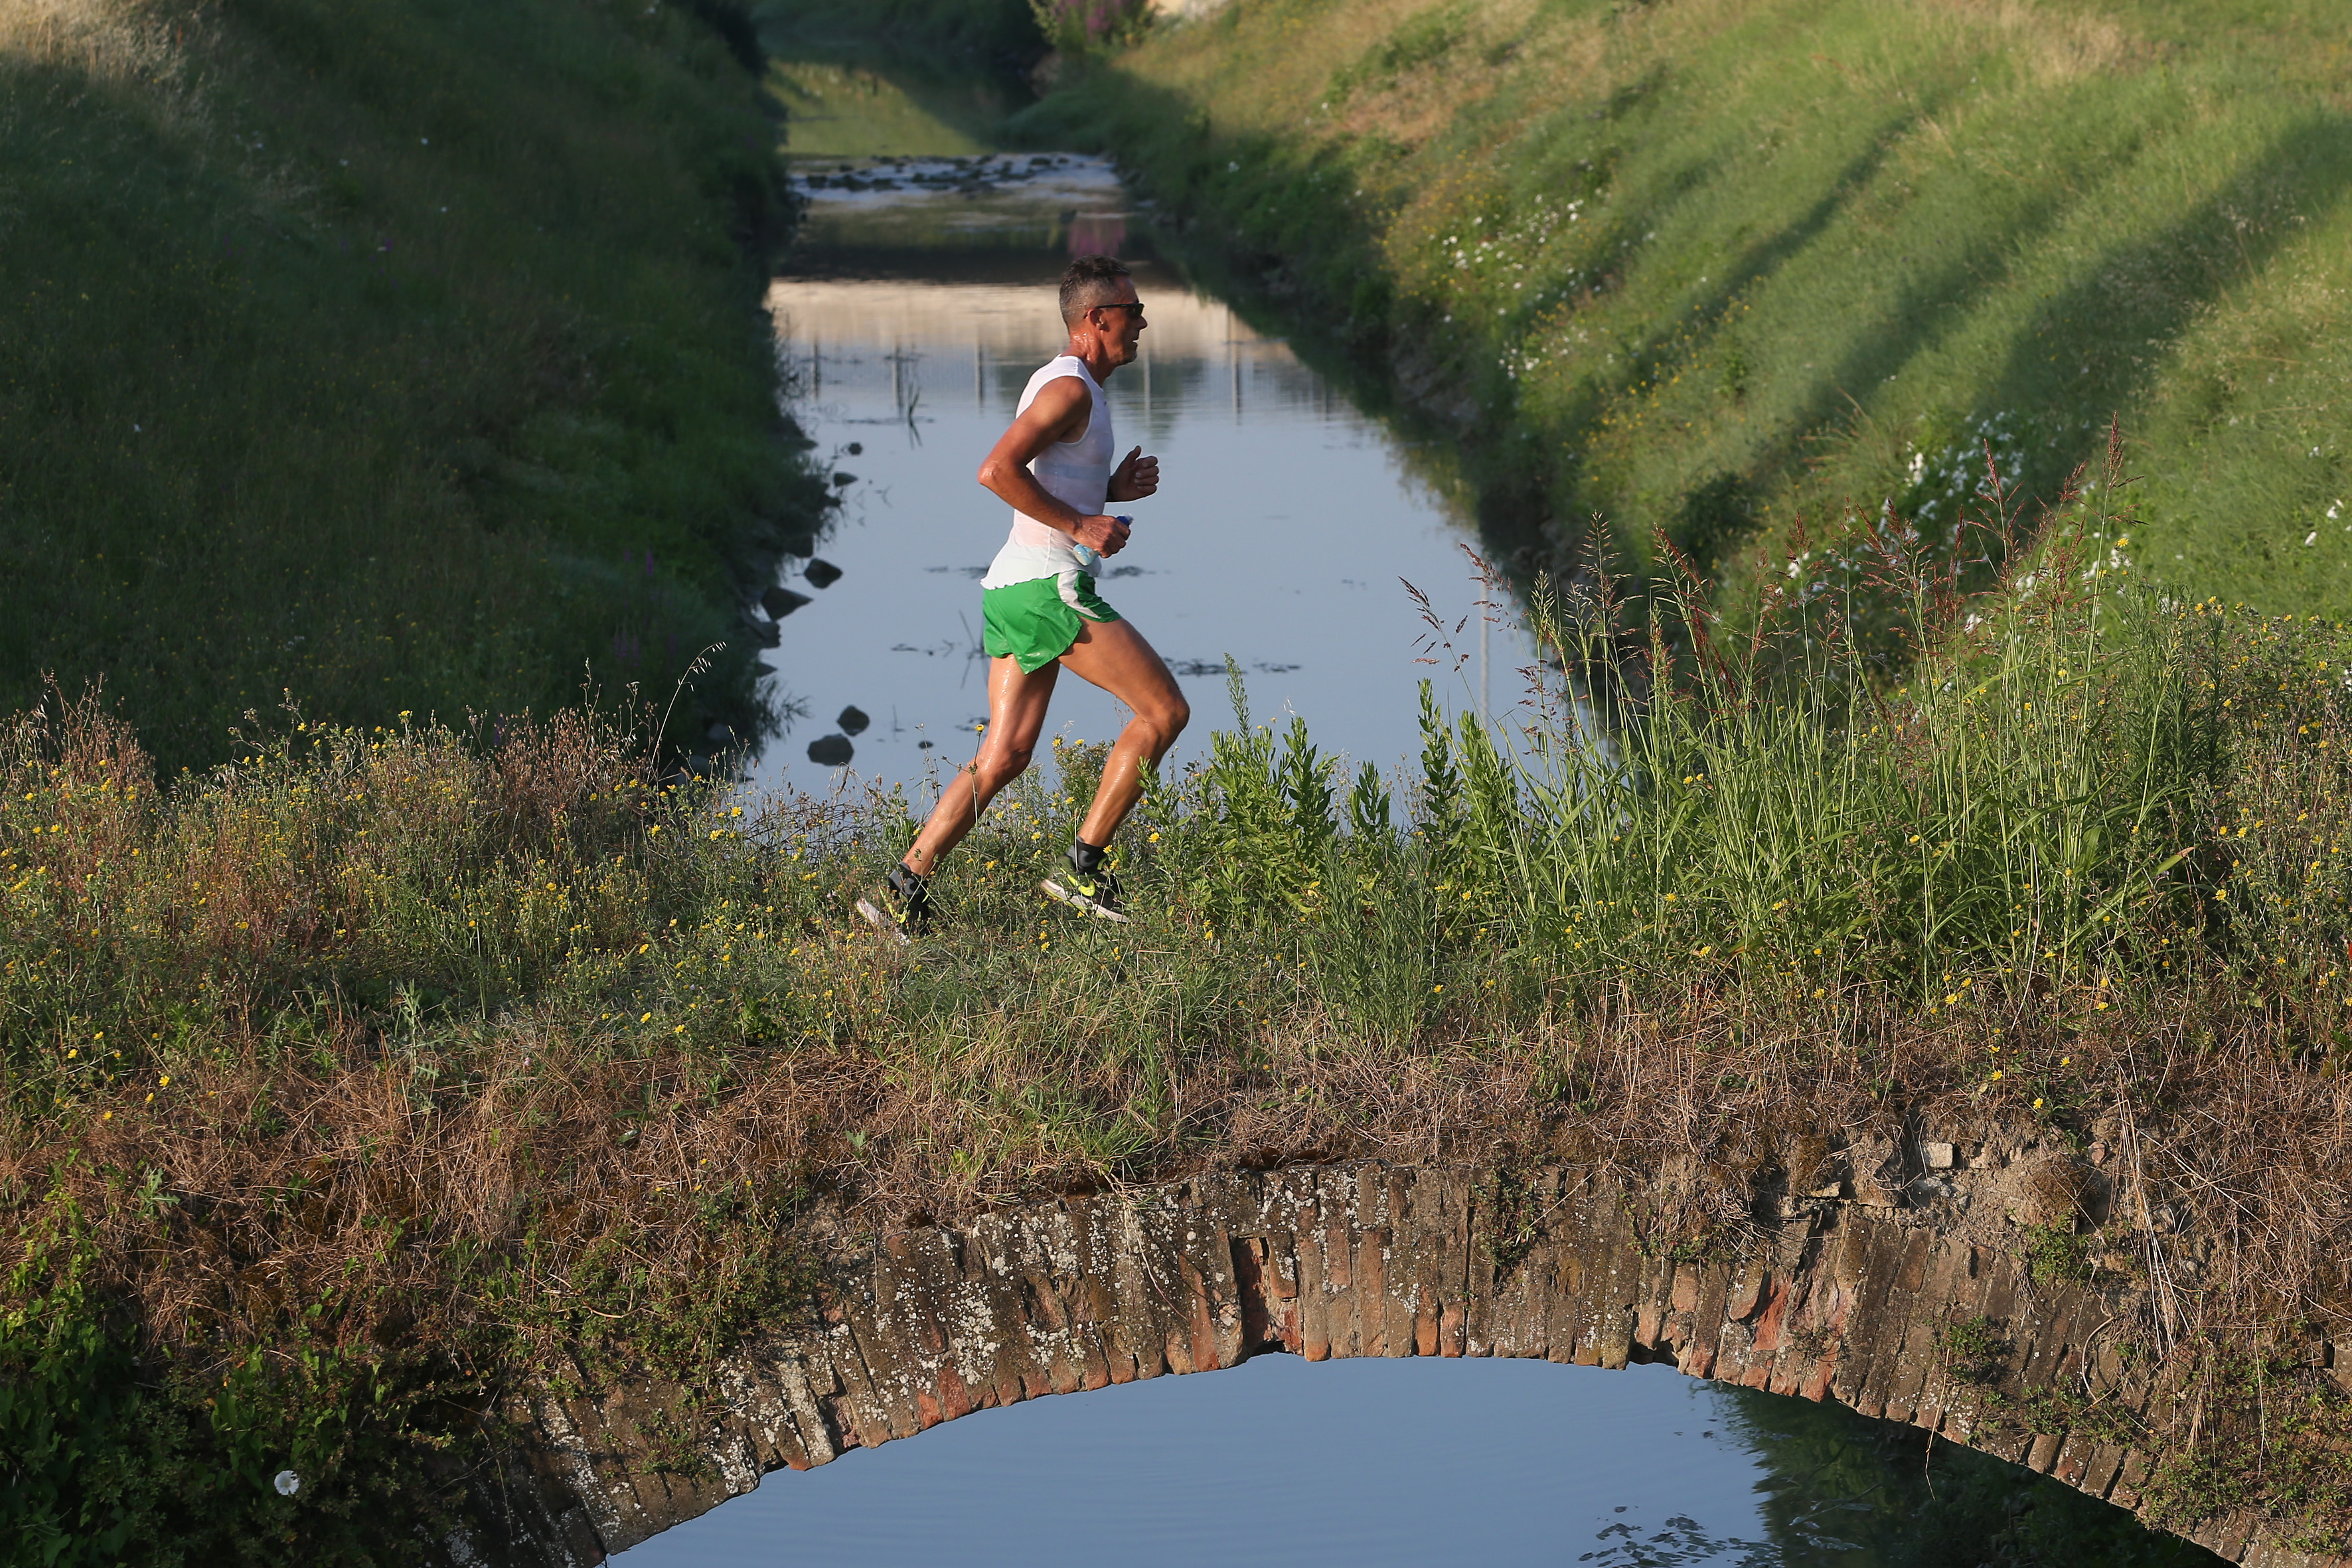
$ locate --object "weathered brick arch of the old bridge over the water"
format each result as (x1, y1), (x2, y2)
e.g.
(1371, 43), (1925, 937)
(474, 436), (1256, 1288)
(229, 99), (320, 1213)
(468, 1161), (2347, 1568)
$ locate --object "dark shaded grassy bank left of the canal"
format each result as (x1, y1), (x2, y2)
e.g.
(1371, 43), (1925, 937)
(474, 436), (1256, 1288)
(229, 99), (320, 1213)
(0, 0), (823, 771)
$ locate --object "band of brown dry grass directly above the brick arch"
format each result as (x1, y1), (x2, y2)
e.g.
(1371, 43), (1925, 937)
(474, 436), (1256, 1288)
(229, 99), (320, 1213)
(23, 799), (2352, 1373)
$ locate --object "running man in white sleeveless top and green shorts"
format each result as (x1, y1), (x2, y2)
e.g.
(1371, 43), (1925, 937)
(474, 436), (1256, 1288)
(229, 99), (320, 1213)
(872, 256), (1192, 929)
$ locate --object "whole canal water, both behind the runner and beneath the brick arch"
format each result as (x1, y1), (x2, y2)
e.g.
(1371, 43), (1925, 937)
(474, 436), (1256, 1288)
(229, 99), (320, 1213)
(659, 92), (2218, 1568)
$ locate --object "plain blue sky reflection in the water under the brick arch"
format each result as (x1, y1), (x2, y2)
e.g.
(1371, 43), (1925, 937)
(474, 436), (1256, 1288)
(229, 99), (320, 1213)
(621, 1356), (1764, 1568)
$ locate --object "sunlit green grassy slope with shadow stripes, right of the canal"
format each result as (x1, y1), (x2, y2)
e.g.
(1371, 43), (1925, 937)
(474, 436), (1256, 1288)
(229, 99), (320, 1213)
(1016, 0), (2352, 613)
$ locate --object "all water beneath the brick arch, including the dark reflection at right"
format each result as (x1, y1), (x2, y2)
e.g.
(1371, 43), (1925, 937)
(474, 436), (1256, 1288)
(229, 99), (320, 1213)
(621, 1354), (2223, 1568)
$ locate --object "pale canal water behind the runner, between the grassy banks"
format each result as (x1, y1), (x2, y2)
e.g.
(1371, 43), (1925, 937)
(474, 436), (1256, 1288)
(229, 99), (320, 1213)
(755, 157), (1526, 795)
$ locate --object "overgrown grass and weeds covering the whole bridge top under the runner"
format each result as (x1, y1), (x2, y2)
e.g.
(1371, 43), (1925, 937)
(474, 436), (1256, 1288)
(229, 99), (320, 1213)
(13, 479), (2352, 1561)
